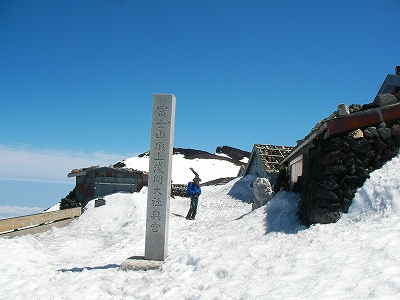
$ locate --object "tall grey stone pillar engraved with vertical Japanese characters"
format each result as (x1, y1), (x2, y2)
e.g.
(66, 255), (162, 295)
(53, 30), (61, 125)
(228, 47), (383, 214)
(144, 94), (176, 261)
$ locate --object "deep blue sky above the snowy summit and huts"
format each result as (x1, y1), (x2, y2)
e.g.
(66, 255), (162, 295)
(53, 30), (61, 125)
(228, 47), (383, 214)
(0, 0), (400, 211)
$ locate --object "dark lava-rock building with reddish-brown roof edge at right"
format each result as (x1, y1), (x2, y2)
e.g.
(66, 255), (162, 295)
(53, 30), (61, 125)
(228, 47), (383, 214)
(282, 68), (400, 225)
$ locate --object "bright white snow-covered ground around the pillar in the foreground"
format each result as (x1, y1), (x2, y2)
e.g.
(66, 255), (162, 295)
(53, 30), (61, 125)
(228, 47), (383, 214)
(0, 157), (400, 300)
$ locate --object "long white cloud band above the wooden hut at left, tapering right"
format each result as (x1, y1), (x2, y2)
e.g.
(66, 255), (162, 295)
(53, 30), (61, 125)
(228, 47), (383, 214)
(0, 145), (134, 182)
